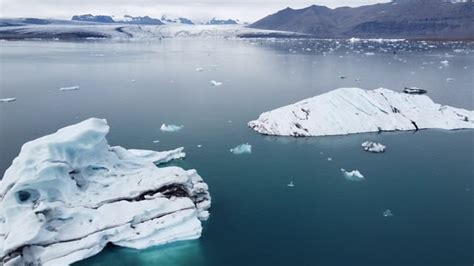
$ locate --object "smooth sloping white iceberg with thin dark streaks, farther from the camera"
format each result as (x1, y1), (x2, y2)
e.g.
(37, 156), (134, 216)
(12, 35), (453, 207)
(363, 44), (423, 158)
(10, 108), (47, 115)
(248, 88), (474, 137)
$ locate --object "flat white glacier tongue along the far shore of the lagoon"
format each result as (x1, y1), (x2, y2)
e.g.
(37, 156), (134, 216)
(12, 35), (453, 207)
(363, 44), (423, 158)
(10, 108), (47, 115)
(0, 22), (305, 41)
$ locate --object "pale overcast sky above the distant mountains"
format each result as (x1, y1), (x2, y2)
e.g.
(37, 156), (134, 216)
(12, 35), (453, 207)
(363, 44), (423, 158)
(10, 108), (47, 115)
(0, 0), (390, 22)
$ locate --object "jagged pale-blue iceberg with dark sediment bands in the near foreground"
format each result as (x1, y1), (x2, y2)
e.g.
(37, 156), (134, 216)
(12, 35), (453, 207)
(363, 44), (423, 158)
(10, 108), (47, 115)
(0, 118), (211, 265)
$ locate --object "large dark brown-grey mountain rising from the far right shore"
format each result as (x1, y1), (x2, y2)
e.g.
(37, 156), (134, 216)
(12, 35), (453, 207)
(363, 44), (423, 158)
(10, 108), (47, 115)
(250, 0), (474, 39)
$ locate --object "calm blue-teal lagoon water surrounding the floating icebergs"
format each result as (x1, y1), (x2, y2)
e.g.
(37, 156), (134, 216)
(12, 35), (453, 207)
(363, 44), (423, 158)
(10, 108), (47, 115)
(0, 39), (474, 266)
